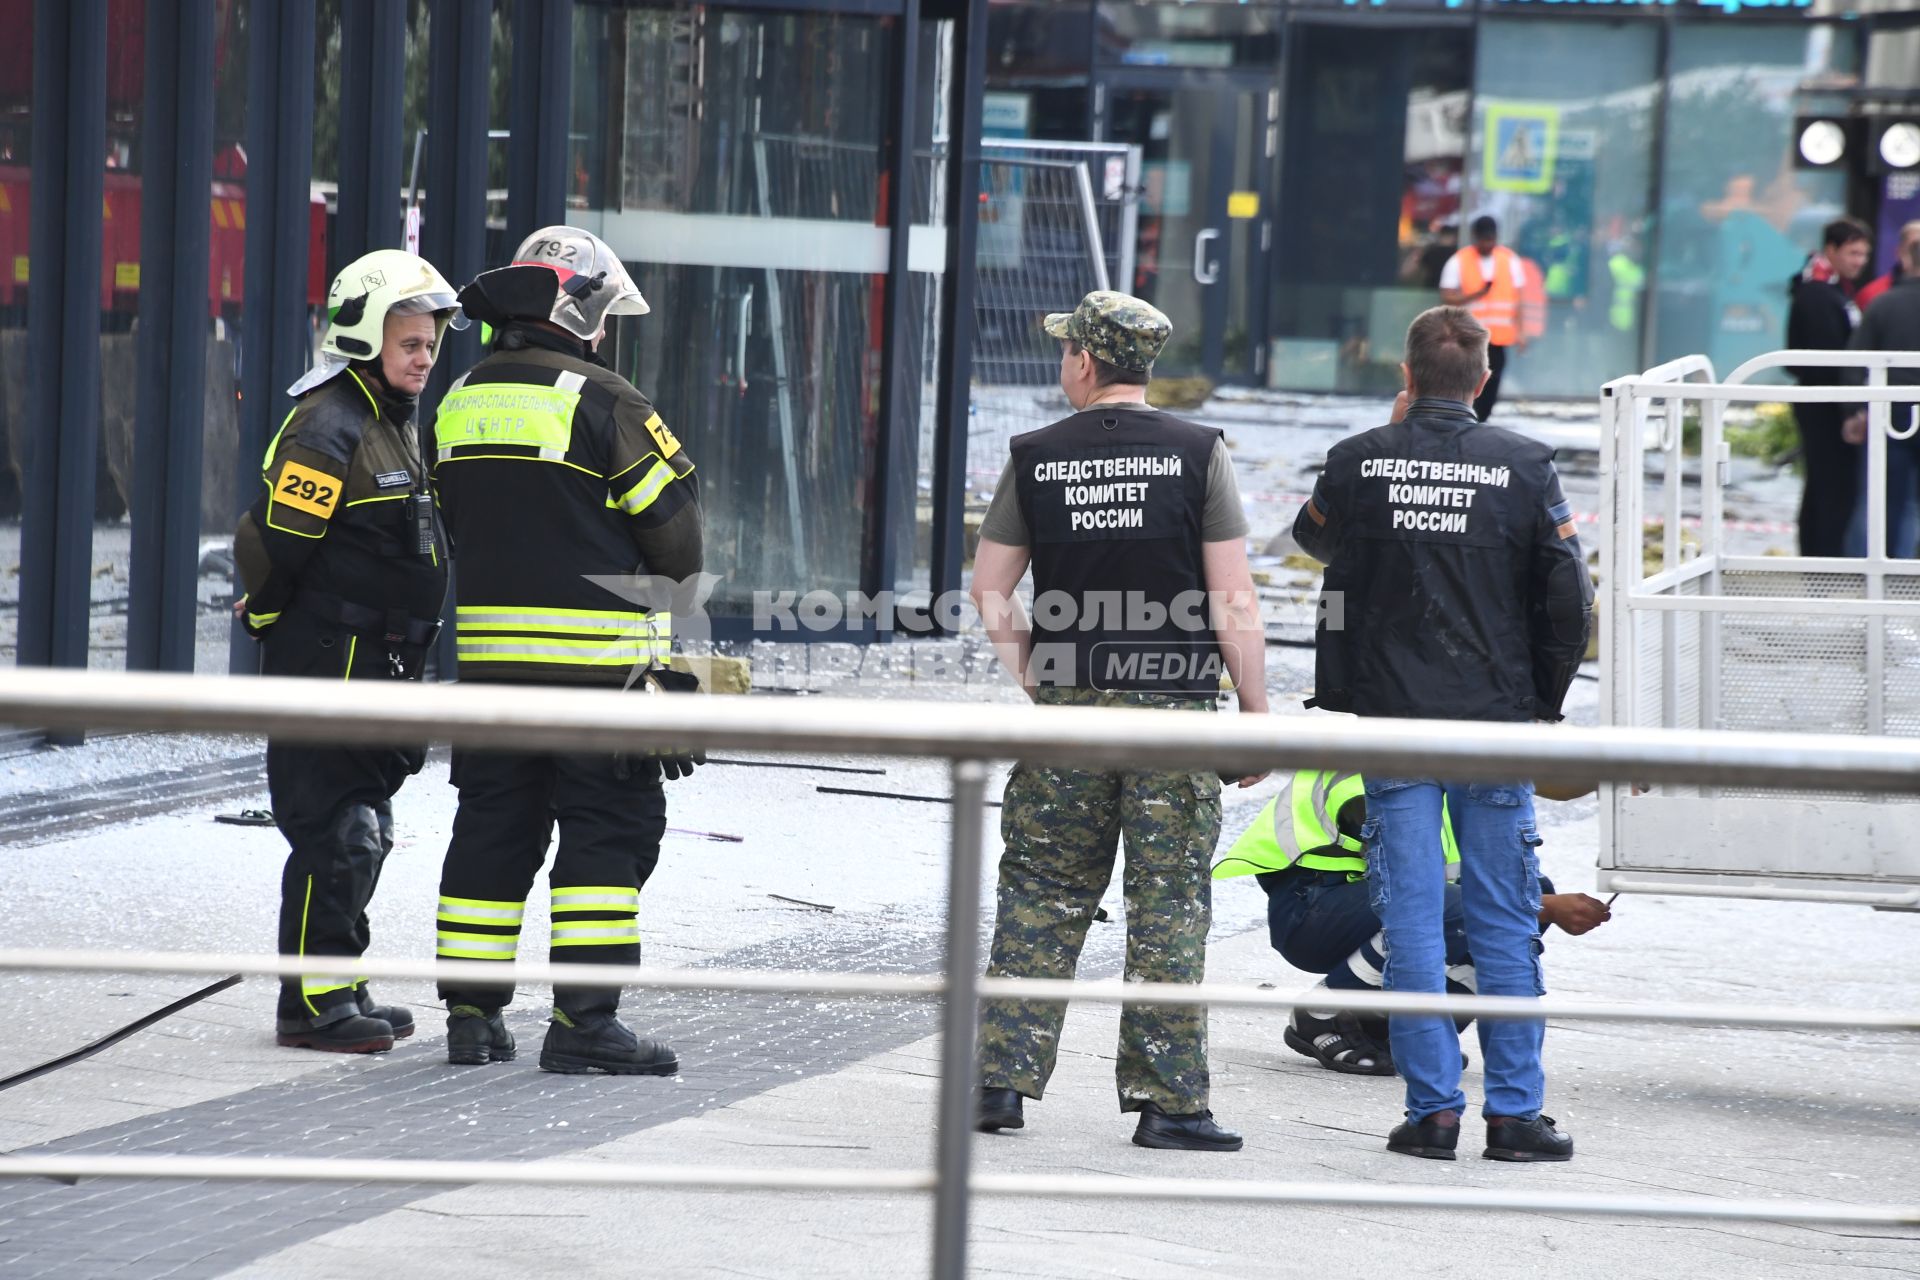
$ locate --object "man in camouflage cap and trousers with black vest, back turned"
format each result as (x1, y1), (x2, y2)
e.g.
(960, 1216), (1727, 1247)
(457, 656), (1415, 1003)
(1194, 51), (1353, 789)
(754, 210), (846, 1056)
(973, 290), (1267, 1151)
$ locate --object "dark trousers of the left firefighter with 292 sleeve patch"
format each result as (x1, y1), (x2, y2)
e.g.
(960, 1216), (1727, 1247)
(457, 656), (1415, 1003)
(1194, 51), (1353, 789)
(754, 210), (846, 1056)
(267, 743), (426, 1025)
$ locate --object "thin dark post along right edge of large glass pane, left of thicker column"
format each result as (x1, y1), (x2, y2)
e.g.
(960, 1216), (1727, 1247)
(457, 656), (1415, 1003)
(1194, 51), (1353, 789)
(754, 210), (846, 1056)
(875, 4), (920, 639)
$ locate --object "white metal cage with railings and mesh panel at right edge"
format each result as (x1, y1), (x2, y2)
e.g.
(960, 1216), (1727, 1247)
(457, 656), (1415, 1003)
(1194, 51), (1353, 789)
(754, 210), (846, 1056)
(1599, 351), (1920, 910)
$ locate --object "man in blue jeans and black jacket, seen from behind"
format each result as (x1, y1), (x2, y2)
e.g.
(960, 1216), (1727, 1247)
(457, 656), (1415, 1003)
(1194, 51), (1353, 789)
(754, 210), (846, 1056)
(1294, 307), (1594, 1161)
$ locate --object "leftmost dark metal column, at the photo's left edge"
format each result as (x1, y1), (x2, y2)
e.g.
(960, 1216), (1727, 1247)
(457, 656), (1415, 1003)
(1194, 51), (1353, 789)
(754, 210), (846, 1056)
(19, 0), (108, 690)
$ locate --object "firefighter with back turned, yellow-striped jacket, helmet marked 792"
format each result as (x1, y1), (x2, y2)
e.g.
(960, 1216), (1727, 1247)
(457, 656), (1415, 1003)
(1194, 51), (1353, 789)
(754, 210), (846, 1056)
(434, 226), (701, 1075)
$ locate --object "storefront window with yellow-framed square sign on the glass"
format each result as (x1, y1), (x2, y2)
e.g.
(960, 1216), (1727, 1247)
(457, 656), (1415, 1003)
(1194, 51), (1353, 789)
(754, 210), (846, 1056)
(1465, 19), (1658, 397)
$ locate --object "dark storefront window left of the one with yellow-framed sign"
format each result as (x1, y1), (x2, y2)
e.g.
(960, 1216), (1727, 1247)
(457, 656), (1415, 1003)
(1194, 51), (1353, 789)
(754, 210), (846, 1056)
(1269, 25), (1473, 393)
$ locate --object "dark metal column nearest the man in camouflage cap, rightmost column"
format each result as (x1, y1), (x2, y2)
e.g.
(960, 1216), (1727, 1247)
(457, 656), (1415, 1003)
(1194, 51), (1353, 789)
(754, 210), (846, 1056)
(933, 0), (987, 612)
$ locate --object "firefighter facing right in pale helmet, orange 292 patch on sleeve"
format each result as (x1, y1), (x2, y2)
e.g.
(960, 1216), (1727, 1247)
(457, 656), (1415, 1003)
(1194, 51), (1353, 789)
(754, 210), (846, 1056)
(234, 249), (465, 1054)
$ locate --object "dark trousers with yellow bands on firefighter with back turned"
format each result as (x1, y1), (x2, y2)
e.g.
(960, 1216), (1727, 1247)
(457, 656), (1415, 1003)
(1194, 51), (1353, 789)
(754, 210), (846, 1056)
(436, 750), (666, 1015)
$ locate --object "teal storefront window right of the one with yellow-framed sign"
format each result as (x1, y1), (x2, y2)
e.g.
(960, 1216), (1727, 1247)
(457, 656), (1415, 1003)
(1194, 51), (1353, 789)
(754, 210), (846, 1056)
(1653, 23), (1855, 372)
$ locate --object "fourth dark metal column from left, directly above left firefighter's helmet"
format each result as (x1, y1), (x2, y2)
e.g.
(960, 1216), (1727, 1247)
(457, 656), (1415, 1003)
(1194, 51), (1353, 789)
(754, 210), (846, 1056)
(328, 0), (405, 276)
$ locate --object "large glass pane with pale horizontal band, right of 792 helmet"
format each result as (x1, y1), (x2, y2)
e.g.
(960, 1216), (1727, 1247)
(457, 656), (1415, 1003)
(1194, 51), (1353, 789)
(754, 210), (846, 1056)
(580, 6), (893, 616)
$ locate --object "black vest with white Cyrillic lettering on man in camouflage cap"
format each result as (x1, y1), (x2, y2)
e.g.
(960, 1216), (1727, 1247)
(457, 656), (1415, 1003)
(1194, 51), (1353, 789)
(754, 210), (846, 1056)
(1012, 405), (1221, 697)
